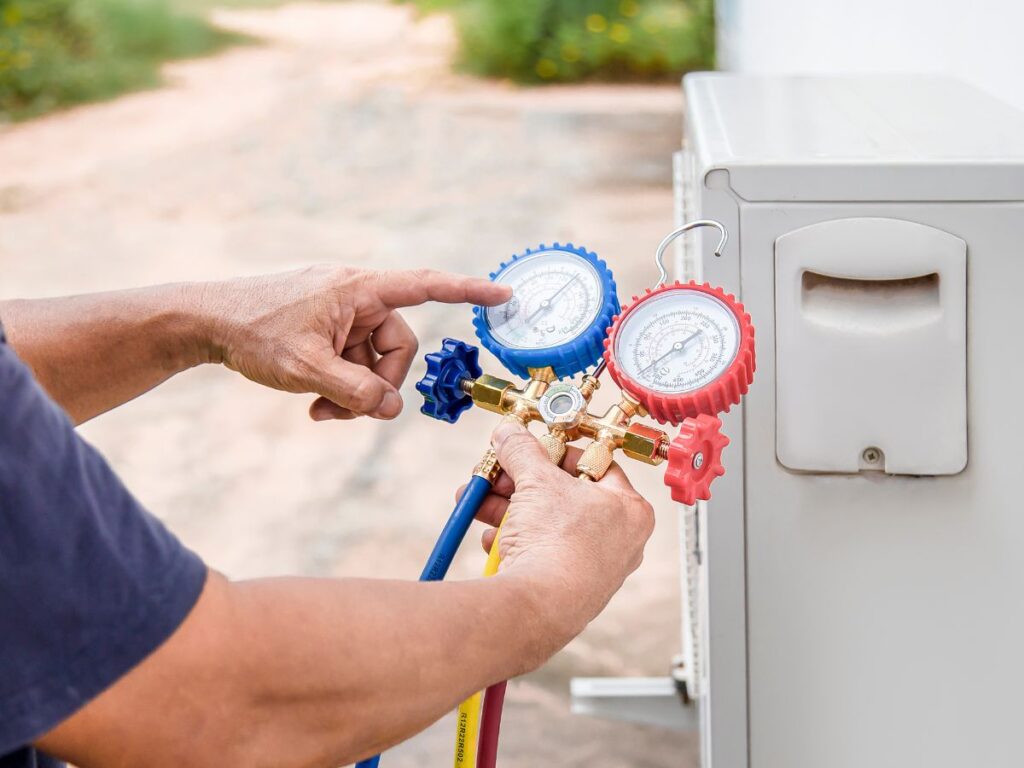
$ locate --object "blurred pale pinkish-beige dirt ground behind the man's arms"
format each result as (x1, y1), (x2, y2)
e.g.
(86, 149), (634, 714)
(0, 2), (697, 768)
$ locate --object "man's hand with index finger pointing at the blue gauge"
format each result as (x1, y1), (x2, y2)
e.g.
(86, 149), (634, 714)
(201, 266), (511, 421)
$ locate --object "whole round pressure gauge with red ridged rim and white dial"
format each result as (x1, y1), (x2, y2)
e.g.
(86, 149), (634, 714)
(606, 284), (754, 423)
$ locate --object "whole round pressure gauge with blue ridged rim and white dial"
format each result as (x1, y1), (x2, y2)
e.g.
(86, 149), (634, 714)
(473, 243), (618, 379)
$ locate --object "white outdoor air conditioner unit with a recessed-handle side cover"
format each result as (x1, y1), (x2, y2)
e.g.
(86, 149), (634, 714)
(677, 74), (1024, 768)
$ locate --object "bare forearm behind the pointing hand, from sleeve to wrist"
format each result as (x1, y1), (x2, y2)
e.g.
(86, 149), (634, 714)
(0, 284), (206, 424)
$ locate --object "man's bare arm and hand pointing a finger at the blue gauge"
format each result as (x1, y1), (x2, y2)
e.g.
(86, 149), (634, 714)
(0, 266), (509, 424)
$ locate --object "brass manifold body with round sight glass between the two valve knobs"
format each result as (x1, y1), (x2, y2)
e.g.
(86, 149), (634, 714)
(460, 364), (670, 480)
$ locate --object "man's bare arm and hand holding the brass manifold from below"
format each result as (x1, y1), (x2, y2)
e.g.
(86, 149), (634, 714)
(37, 424), (653, 768)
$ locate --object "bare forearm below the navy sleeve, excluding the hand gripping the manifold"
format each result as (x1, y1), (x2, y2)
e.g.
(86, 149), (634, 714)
(39, 573), (569, 768)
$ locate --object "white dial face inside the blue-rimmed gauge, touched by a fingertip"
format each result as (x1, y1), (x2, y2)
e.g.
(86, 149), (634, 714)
(483, 249), (604, 349)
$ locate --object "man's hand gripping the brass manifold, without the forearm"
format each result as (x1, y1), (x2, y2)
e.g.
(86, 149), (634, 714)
(460, 421), (654, 652)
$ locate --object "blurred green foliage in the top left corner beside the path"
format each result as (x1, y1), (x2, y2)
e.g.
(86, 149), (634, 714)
(0, 0), (236, 120)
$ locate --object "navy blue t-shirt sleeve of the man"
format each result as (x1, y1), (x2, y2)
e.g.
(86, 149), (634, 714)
(0, 330), (206, 756)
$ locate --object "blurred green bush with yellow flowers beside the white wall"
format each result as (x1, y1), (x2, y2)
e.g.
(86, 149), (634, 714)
(399, 0), (715, 83)
